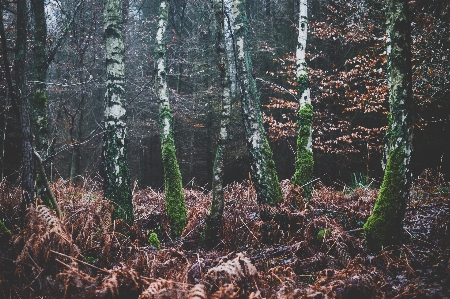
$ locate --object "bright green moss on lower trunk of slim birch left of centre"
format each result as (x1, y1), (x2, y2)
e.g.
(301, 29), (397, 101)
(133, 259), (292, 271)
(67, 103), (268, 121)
(161, 125), (187, 237)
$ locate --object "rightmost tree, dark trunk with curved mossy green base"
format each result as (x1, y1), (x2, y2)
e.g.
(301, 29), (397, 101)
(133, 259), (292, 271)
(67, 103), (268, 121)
(364, 0), (412, 250)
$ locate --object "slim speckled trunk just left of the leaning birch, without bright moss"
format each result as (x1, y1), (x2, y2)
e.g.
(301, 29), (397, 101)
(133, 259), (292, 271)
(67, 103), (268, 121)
(205, 0), (231, 248)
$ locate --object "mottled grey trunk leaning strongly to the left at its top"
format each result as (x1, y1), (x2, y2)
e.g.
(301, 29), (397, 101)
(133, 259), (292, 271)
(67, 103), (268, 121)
(233, 0), (282, 209)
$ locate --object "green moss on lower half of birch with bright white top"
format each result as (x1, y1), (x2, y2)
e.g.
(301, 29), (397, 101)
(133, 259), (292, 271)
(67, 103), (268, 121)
(292, 104), (314, 198)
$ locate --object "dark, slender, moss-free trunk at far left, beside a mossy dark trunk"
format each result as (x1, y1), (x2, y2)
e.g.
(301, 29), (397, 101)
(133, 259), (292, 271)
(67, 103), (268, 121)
(14, 0), (34, 215)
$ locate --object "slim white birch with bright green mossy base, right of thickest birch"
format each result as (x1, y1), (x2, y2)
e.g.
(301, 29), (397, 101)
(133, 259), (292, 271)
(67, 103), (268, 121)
(155, 0), (187, 237)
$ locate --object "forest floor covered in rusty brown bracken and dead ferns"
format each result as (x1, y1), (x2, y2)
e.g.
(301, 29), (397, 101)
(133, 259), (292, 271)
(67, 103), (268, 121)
(0, 172), (450, 298)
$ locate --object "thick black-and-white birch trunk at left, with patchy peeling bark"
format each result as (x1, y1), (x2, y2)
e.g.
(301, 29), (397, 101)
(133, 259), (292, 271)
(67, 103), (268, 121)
(102, 0), (134, 223)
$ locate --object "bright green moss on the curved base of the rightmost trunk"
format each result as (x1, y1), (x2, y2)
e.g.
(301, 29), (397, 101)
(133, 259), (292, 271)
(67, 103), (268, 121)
(364, 148), (407, 251)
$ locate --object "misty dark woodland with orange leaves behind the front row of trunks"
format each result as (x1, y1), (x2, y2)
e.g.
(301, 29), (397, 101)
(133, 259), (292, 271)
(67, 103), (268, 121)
(0, 0), (450, 189)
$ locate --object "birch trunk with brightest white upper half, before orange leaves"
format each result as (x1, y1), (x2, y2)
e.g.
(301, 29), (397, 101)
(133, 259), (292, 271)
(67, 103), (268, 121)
(292, 0), (314, 198)
